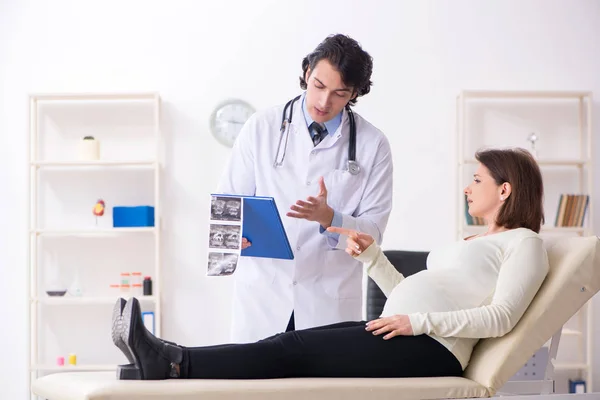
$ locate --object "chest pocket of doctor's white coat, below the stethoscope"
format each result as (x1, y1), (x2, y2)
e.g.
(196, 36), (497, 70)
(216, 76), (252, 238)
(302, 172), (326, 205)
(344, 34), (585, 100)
(325, 169), (362, 214)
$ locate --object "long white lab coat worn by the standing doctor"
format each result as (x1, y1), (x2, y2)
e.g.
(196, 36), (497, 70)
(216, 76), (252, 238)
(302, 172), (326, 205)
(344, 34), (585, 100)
(218, 94), (393, 343)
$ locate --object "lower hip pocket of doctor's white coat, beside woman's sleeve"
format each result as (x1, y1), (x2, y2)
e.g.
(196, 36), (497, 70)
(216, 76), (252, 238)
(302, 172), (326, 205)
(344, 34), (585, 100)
(319, 249), (362, 300)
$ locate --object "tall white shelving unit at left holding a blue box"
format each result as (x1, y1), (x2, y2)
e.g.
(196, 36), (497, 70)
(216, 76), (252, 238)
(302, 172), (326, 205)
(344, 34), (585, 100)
(29, 89), (165, 399)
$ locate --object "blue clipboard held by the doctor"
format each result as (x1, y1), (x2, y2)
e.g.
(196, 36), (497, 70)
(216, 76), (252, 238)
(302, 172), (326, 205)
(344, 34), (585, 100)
(212, 194), (294, 260)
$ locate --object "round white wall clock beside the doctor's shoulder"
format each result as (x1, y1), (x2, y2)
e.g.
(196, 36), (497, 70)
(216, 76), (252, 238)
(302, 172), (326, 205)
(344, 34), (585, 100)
(210, 99), (255, 147)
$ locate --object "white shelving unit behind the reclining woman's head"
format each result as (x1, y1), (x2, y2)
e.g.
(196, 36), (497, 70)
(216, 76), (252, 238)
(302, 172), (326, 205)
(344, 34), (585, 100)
(455, 88), (598, 392)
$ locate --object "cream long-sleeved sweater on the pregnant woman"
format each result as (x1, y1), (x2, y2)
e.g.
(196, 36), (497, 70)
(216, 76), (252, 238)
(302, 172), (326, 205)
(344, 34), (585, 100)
(356, 228), (548, 369)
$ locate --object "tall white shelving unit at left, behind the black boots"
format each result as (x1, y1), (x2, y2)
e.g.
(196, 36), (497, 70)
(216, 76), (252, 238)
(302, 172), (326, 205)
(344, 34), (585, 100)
(27, 93), (163, 396)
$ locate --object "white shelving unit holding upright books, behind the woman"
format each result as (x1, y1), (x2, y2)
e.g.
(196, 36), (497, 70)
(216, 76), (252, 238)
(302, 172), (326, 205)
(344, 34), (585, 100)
(456, 90), (594, 392)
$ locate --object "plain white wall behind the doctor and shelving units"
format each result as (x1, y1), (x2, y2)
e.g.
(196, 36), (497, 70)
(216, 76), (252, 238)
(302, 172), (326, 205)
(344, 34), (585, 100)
(0, 0), (600, 399)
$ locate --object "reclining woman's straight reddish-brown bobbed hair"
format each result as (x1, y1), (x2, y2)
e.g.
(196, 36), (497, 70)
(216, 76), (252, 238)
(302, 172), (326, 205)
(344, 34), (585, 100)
(475, 148), (544, 233)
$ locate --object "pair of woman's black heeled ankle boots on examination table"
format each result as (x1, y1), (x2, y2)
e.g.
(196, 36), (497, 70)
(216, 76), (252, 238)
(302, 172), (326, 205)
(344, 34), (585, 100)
(117, 297), (183, 380)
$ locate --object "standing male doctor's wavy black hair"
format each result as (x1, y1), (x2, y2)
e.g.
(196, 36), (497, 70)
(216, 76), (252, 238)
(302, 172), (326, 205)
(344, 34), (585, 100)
(300, 34), (373, 105)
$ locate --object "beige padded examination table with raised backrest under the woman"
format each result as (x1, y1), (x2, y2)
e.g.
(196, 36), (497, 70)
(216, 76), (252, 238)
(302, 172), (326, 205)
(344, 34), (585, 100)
(31, 236), (600, 400)
